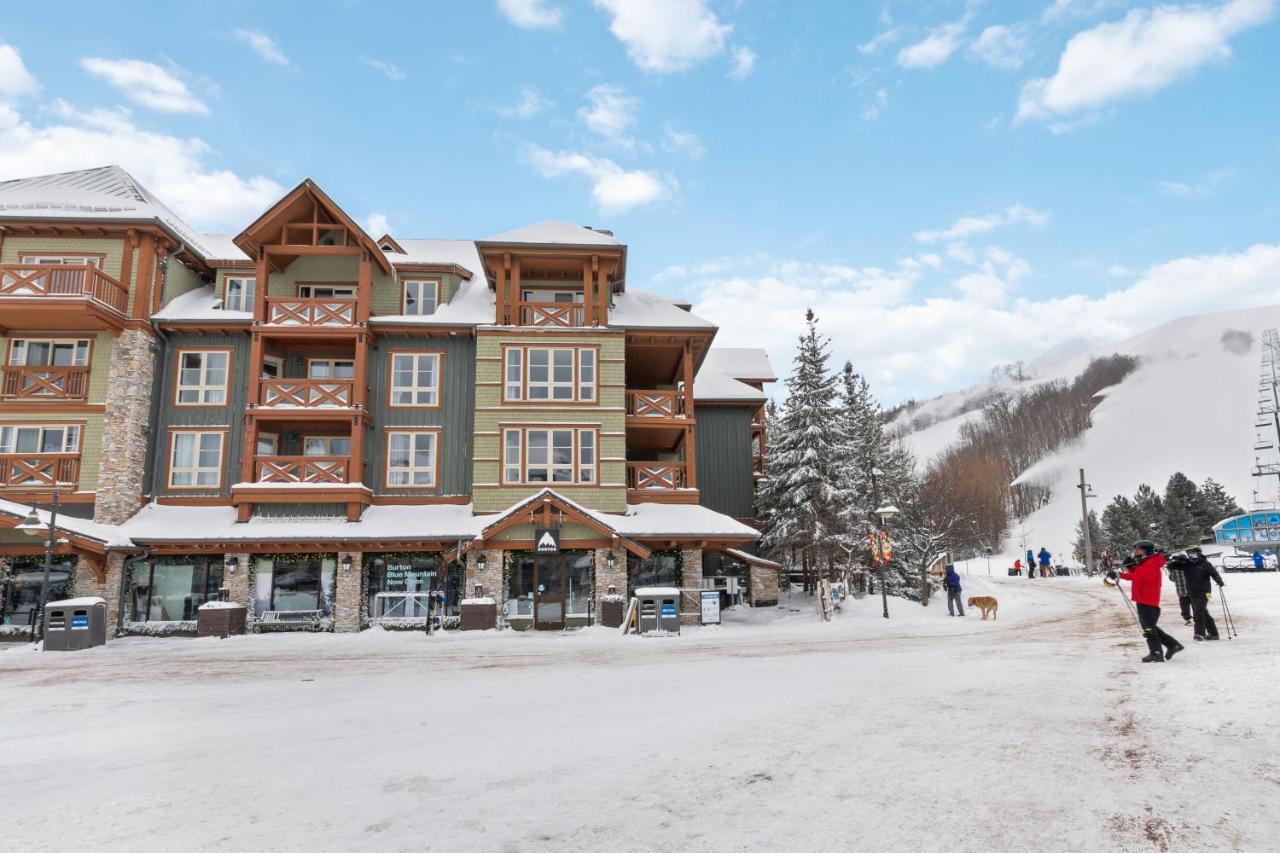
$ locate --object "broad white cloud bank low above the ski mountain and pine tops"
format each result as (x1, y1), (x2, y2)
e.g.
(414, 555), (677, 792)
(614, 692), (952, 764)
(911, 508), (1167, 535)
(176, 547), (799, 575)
(680, 239), (1280, 402)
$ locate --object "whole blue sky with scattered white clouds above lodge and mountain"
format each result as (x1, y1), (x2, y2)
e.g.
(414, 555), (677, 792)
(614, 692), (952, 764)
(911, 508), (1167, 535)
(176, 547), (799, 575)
(0, 0), (1280, 402)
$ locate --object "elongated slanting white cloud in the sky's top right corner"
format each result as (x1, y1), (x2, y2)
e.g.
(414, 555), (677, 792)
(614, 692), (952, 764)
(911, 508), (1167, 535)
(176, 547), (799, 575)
(1018, 0), (1275, 119)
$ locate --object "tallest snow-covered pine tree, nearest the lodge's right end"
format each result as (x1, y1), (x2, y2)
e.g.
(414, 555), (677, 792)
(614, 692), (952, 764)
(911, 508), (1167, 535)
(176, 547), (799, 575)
(762, 310), (841, 592)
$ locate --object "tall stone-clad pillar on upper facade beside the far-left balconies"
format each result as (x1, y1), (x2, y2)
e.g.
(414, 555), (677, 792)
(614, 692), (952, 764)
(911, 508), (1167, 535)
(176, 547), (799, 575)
(93, 329), (155, 524)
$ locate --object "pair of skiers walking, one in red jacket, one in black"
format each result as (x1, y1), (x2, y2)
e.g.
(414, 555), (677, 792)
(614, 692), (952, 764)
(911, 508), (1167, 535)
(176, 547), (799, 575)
(1107, 539), (1224, 663)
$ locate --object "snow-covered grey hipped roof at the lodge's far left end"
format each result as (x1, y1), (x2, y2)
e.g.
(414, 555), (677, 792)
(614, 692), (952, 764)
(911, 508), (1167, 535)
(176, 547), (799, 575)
(0, 165), (209, 257)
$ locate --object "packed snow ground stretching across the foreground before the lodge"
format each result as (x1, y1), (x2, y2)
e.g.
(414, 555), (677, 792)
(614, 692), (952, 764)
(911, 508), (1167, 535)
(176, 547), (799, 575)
(0, 570), (1280, 850)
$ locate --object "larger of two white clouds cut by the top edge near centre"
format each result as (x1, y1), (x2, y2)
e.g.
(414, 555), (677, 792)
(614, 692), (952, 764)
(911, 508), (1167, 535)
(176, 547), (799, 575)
(593, 0), (733, 74)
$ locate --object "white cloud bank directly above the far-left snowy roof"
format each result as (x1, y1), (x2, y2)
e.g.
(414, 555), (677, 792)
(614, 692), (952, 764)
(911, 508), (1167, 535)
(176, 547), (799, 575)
(0, 101), (284, 231)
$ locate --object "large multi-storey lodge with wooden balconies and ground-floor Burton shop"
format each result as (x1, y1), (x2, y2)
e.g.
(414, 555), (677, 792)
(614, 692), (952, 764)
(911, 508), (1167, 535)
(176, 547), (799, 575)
(0, 167), (777, 634)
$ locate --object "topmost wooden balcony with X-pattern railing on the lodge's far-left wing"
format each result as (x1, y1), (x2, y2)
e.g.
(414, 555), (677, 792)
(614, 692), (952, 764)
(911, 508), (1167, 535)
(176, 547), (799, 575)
(0, 264), (129, 330)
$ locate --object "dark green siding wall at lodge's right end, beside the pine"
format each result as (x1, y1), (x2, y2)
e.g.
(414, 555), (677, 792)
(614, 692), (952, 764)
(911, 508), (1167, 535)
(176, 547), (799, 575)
(694, 406), (755, 519)
